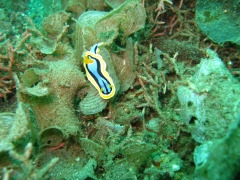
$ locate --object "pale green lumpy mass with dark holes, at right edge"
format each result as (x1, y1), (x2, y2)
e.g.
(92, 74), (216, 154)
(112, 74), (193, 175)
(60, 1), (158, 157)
(178, 50), (240, 143)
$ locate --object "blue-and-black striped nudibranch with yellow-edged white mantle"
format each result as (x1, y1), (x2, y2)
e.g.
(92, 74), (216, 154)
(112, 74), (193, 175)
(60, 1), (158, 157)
(83, 43), (116, 99)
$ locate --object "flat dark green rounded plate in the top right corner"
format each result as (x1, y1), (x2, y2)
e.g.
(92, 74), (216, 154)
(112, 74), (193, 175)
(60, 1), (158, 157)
(196, 0), (240, 45)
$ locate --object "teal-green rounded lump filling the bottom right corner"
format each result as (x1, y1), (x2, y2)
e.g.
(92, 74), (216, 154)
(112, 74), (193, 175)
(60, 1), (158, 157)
(194, 117), (240, 180)
